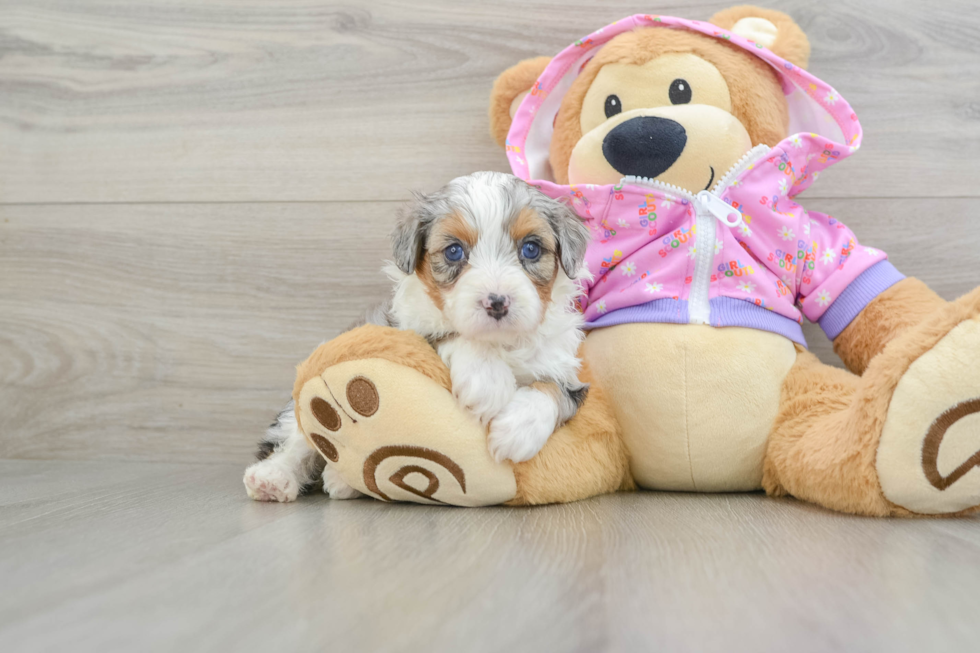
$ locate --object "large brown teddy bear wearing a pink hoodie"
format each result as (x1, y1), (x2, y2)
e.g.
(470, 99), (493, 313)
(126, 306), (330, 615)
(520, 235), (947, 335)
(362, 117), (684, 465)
(293, 6), (980, 516)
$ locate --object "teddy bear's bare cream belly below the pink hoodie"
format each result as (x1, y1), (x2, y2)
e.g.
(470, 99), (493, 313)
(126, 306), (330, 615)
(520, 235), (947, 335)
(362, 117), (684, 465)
(584, 324), (796, 492)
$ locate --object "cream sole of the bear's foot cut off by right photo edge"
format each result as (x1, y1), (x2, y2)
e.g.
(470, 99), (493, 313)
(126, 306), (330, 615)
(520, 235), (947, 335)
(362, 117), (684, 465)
(876, 316), (980, 514)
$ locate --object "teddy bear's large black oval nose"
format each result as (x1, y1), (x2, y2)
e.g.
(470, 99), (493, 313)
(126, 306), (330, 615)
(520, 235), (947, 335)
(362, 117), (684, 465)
(602, 116), (687, 178)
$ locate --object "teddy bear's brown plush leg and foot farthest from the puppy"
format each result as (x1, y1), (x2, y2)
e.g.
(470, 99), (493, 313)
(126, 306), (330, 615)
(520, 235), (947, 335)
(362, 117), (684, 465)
(763, 290), (980, 516)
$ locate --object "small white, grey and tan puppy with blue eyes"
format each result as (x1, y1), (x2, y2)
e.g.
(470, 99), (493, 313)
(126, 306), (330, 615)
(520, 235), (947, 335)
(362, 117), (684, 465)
(245, 172), (589, 501)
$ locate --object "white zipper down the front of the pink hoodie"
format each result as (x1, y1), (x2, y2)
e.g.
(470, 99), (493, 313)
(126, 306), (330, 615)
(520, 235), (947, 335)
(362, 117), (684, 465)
(620, 145), (769, 324)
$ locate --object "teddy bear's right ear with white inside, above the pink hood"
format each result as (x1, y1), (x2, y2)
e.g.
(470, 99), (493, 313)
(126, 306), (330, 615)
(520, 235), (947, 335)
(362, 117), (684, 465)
(711, 5), (810, 68)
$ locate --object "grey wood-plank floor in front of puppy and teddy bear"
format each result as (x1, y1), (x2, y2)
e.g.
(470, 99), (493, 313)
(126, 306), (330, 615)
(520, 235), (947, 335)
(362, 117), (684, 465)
(0, 460), (980, 653)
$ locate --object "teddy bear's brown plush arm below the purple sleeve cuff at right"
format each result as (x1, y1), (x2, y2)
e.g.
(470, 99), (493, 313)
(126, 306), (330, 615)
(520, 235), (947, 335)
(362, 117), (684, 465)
(834, 277), (947, 374)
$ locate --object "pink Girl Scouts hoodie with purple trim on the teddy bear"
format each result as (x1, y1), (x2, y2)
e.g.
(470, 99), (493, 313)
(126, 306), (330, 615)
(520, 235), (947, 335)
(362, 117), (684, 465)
(507, 14), (903, 345)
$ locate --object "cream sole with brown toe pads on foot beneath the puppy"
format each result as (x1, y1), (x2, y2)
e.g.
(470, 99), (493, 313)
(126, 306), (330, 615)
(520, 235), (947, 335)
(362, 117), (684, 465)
(298, 359), (517, 506)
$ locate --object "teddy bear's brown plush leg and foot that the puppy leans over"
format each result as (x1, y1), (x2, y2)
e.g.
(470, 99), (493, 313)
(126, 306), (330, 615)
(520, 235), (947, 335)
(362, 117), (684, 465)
(293, 325), (628, 506)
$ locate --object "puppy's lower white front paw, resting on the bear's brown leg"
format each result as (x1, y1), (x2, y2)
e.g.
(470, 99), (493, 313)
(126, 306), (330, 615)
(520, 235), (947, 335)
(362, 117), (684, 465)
(487, 388), (558, 463)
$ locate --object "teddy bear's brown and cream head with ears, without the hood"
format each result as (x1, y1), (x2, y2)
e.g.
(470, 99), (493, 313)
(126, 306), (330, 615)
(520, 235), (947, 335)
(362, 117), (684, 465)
(490, 6), (810, 193)
